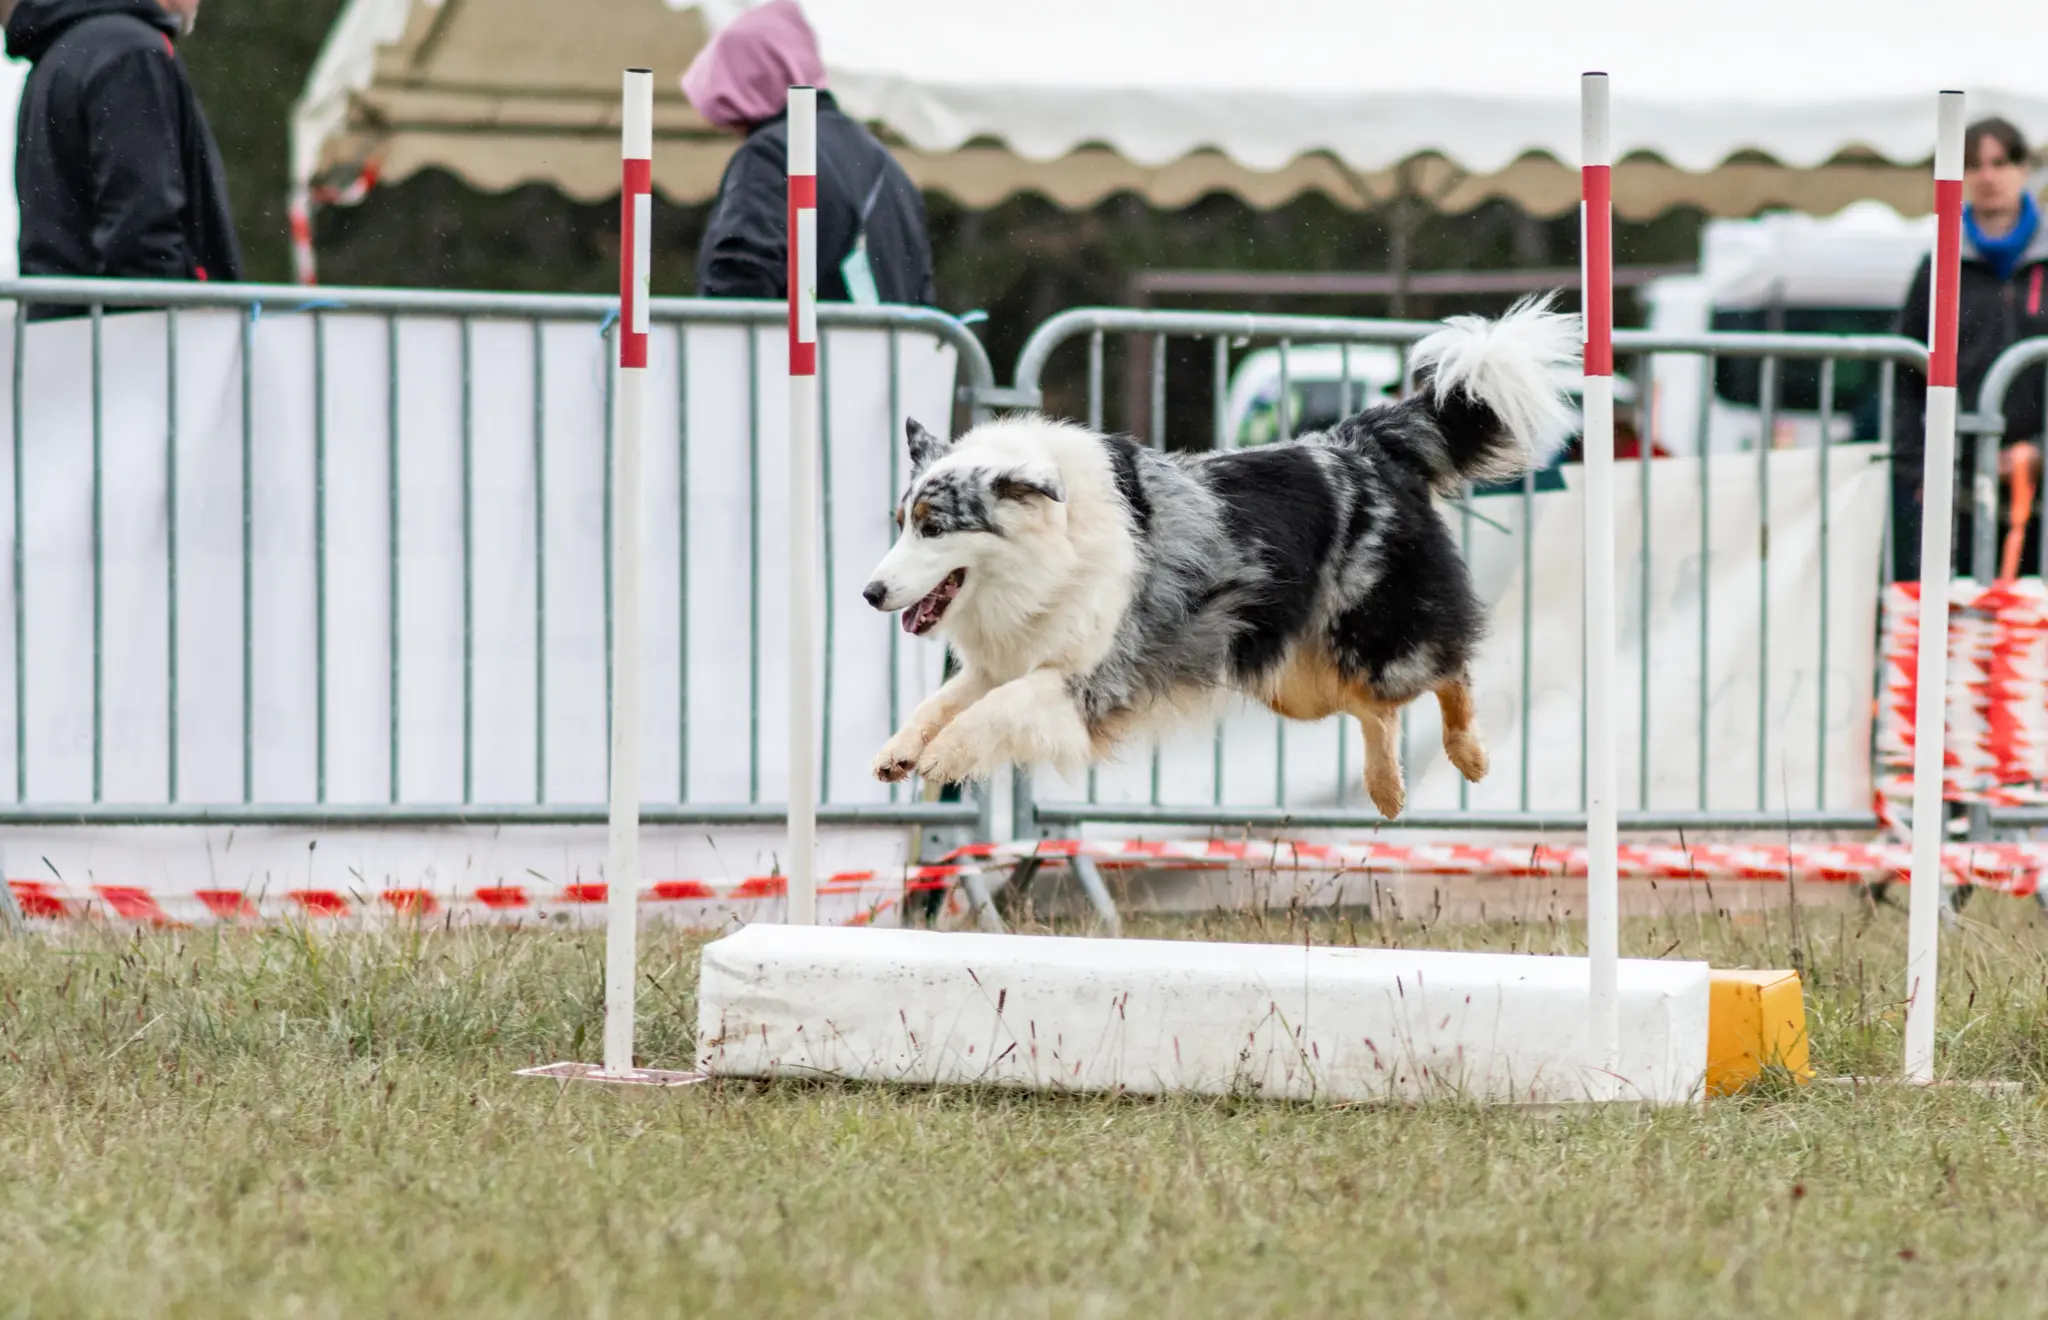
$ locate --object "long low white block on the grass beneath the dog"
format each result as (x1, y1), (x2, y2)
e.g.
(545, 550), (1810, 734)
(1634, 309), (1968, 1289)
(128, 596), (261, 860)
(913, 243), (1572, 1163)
(696, 923), (1710, 1105)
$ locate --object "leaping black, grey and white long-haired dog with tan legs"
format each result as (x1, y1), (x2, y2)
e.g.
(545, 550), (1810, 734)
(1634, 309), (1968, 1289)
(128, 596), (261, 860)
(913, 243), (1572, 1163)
(868, 294), (1577, 817)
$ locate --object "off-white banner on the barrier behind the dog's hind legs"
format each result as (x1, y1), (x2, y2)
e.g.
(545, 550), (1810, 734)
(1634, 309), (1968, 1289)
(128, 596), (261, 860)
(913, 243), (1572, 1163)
(1038, 444), (1888, 812)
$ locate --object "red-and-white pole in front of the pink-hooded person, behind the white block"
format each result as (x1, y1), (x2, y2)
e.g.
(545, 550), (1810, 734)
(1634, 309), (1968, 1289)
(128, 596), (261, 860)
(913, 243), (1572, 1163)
(788, 88), (819, 925)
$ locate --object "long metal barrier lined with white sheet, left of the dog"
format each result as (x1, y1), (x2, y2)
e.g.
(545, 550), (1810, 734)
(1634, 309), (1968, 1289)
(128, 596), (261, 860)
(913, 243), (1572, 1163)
(0, 278), (1001, 833)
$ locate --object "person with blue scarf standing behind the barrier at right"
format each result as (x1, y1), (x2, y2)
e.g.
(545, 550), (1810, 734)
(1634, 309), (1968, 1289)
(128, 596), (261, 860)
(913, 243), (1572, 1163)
(1892, 119), (2048, 581)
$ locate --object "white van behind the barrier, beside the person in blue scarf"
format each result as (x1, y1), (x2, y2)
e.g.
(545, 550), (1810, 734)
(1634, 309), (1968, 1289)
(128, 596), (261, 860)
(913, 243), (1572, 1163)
(1642, 203), (1933, 454)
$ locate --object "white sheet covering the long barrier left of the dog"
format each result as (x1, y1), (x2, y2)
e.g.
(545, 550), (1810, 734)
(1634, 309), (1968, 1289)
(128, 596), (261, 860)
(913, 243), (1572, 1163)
(0, 302), (954, 892)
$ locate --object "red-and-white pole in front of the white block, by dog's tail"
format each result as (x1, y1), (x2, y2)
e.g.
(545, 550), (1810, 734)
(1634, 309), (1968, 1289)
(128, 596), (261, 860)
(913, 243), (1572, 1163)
(1579, 74), (1622, 1068)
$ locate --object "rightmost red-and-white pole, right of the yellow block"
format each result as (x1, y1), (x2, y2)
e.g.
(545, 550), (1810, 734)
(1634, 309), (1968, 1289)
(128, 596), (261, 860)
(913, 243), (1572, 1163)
(1905, 92), (1964, 1083)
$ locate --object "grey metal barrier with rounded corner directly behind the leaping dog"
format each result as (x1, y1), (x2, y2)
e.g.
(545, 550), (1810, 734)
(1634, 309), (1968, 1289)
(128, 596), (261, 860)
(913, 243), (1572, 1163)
(1014, 309), (1925, 837)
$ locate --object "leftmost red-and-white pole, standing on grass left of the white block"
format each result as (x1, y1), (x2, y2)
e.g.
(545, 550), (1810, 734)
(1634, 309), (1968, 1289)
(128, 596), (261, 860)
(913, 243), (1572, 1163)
(604, 70), (653, 1076)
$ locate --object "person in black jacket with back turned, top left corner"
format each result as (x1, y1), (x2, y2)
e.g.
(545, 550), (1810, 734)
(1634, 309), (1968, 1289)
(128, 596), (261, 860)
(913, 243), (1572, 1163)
(0, 0), (242, 317)
